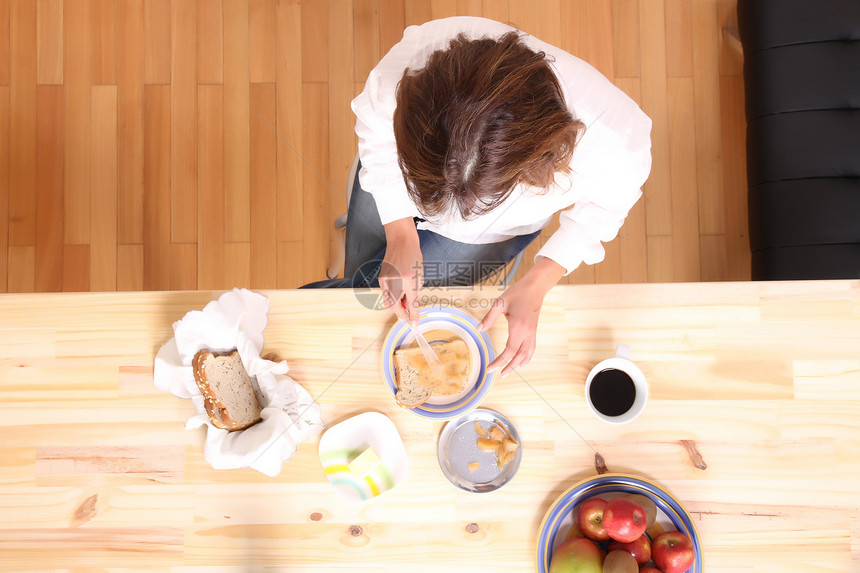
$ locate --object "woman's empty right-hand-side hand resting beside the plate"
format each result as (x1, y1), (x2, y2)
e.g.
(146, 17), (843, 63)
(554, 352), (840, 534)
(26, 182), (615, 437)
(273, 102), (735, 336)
(478, 257), (565, 378)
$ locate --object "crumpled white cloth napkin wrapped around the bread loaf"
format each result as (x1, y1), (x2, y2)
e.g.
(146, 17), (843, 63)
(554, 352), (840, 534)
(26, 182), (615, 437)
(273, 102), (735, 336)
(154, 289), (324, 477)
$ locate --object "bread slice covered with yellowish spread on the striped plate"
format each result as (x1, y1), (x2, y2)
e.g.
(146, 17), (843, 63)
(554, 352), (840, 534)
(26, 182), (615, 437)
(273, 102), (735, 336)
(394, 338), (471, 408)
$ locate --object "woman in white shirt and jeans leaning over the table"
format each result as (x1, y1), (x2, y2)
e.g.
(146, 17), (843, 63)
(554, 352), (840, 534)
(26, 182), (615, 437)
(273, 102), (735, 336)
(309, 17), (651, 376)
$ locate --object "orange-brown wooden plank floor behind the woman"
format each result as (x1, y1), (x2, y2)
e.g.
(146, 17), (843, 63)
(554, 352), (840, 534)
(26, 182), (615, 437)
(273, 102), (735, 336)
(0, 0), (749, 292)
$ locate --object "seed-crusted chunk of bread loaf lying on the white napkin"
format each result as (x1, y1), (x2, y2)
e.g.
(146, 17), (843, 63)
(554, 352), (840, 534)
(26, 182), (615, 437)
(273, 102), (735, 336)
(192, 350), (263, 432)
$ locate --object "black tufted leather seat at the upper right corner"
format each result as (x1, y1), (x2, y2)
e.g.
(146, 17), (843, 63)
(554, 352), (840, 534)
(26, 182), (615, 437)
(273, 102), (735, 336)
(738, 0), (860, 280)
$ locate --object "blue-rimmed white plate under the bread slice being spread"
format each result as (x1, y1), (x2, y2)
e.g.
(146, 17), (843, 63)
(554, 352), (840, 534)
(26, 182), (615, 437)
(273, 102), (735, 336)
(382, 305), (496, 420)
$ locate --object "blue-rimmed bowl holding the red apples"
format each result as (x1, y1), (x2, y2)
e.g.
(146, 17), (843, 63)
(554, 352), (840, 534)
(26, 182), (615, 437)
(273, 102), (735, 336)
(535, 474), (705, 573)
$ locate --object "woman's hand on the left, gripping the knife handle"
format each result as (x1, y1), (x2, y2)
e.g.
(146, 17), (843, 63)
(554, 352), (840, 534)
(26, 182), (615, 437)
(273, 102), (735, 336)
(379, 218), (424, 325)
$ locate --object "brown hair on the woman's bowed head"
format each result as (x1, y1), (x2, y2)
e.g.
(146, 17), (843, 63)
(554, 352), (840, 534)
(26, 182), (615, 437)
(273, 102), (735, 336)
(394, 32), (584, 219)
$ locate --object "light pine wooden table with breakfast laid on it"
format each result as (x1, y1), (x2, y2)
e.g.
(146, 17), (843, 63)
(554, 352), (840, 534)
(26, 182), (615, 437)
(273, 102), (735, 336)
(0, 281), (860, 573)
